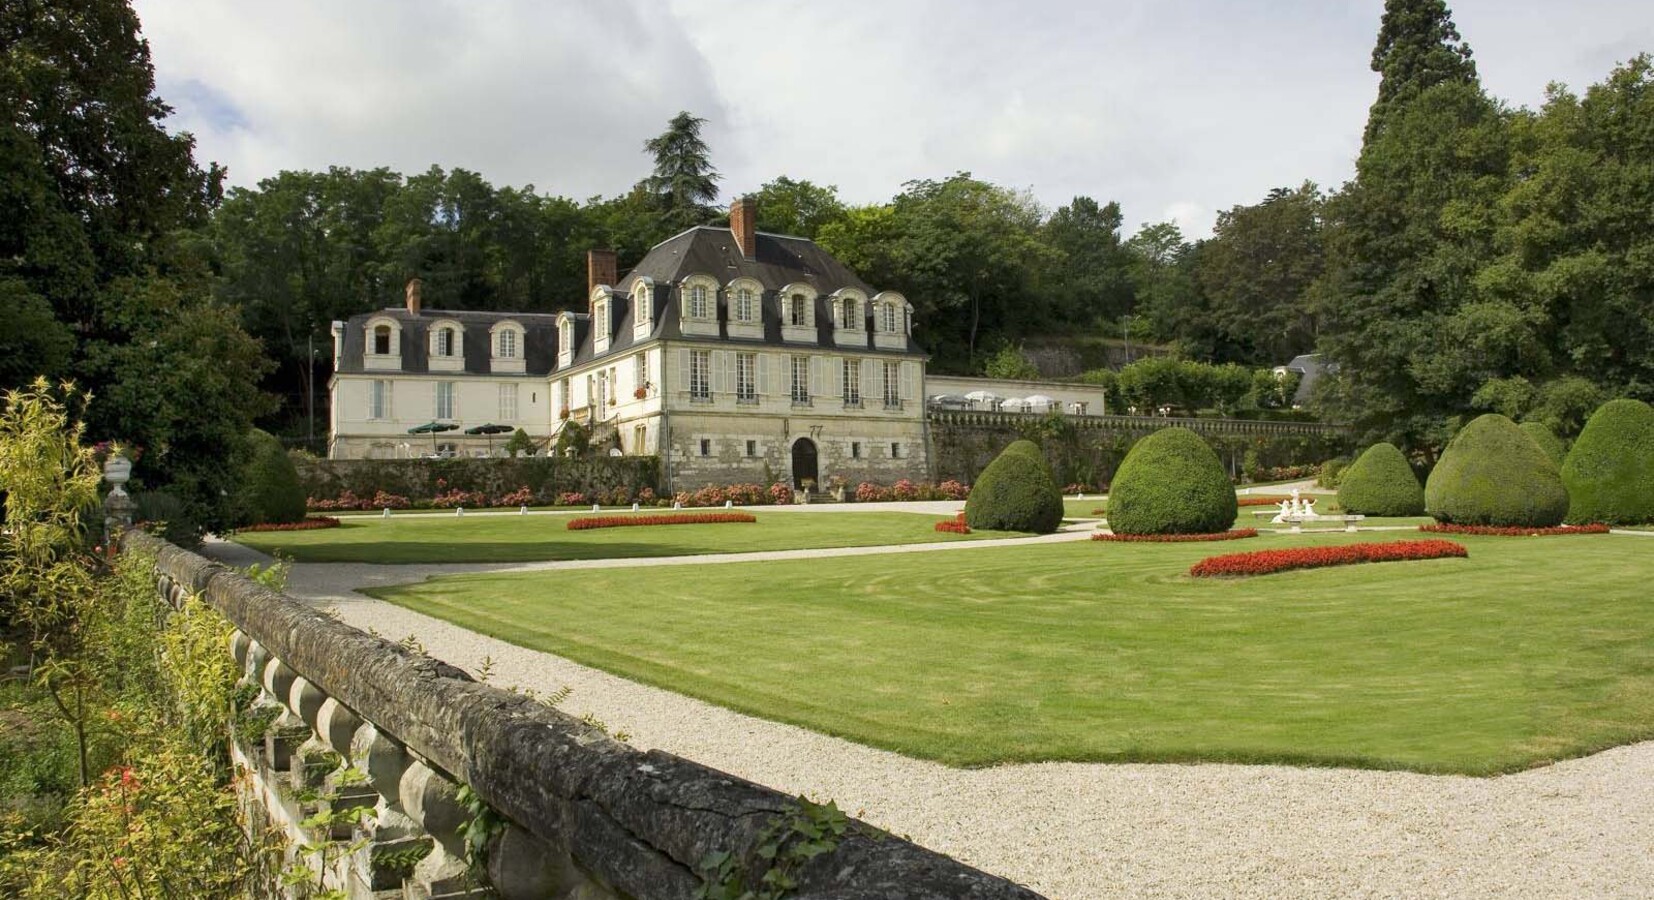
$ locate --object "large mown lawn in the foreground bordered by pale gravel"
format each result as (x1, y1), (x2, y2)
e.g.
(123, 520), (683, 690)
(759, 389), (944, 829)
(374, 536), (1654, 774)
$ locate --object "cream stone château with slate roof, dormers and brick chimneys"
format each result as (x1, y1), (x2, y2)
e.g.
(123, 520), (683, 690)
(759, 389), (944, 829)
(329, 199), (930, 490)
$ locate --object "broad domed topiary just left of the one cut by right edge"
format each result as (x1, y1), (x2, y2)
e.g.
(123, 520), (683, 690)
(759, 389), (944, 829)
(1424, 414), (1568, 528)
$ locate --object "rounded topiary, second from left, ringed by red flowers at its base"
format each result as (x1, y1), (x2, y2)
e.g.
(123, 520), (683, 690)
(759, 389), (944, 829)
(1108, 428), (1236, 534)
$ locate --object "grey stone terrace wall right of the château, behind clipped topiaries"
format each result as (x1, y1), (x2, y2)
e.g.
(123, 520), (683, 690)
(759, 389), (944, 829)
(930, 410), (1351, 485)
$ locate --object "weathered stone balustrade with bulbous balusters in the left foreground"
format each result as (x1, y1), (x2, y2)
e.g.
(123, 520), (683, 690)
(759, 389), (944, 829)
(122, 531), (1037, 900)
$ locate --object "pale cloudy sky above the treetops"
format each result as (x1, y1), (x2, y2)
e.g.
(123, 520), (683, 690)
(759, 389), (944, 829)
(136, 0), (1654, 235)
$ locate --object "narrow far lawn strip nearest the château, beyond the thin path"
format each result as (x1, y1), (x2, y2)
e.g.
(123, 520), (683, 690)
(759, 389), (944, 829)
(235, 510), (1016, 563)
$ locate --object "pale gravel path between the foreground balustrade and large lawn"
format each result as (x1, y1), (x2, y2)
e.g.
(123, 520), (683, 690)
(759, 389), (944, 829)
(200, 536), (1654, 898)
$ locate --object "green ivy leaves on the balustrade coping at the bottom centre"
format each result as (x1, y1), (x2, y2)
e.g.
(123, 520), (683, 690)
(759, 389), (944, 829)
(695, 796), (853, 900)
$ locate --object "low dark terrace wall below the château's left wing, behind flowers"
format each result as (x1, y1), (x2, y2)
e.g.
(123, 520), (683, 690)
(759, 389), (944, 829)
(294, 457), (660, 503)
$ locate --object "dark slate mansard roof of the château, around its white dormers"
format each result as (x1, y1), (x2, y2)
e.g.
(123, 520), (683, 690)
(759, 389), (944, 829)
(339, 225), (925, 376)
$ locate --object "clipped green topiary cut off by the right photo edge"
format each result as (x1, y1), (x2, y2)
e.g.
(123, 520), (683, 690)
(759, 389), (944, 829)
(1561, 400), (1654, 524)
